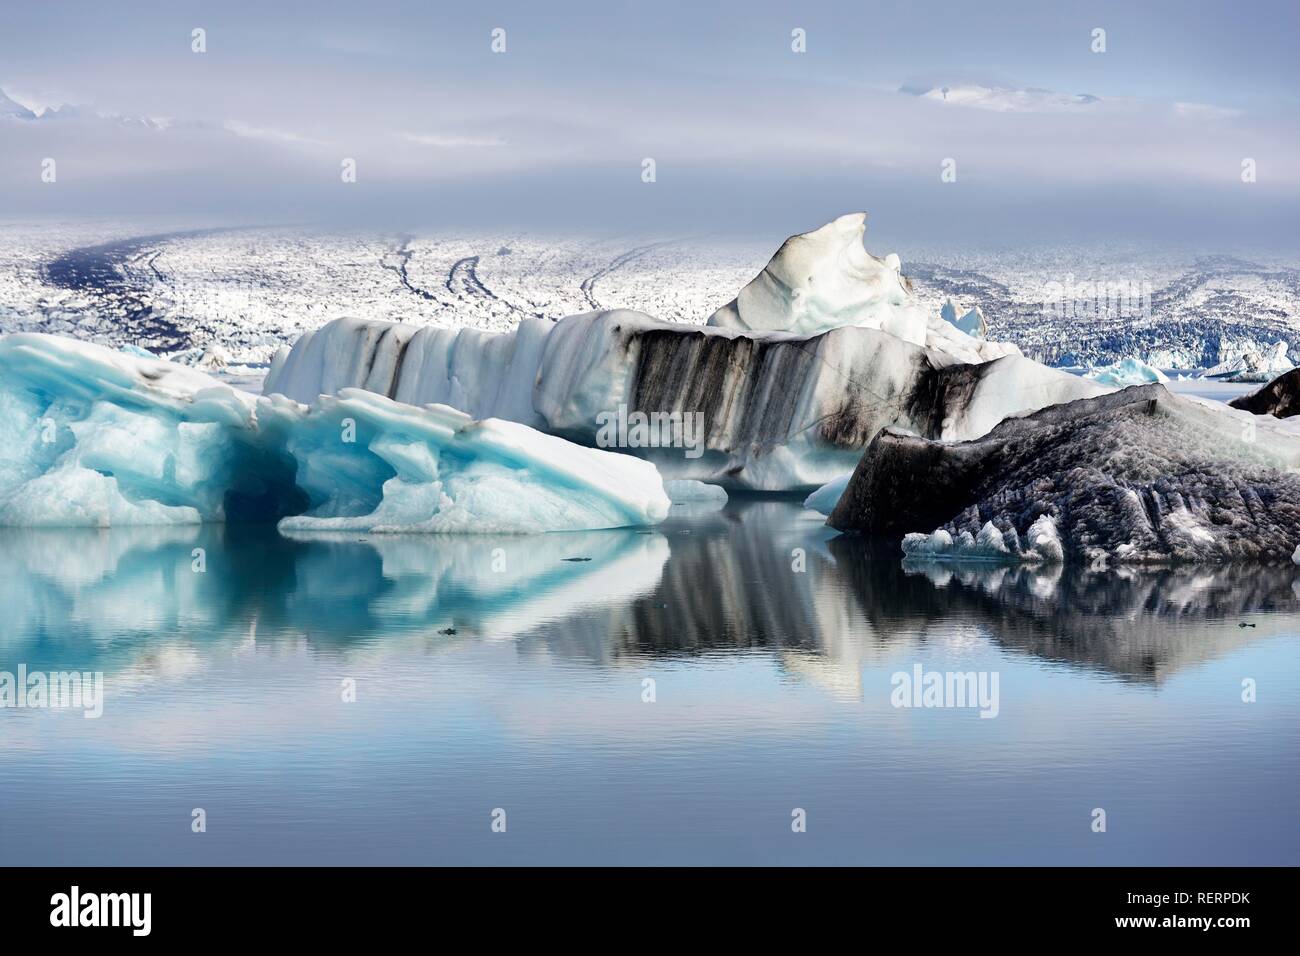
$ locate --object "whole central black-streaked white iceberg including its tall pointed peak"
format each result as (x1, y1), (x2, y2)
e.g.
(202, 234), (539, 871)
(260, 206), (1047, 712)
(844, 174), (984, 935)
(263, 213), (1104, 493)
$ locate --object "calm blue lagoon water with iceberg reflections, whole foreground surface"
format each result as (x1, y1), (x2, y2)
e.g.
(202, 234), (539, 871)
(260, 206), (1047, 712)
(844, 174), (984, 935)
(0, 499), (1300, 865)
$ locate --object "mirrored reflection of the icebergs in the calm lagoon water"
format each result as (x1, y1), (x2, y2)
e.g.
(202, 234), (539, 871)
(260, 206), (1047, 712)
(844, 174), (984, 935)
(0, 498), (1300, 689)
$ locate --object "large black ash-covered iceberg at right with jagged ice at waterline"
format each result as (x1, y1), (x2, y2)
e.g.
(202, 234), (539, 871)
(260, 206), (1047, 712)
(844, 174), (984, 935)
(828, 385), (1300, 564)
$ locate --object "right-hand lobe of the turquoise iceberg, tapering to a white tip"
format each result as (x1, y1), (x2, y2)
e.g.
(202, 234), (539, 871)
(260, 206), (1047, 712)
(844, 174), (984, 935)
(267, 389), (668, 532)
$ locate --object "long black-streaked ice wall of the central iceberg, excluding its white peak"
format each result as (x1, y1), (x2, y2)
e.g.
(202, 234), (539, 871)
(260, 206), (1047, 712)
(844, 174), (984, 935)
(264, 310), (1101, 490)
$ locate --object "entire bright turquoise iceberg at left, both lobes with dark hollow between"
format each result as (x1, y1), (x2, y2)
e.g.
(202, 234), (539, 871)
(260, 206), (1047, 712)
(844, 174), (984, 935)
(0, 334), (670, 532)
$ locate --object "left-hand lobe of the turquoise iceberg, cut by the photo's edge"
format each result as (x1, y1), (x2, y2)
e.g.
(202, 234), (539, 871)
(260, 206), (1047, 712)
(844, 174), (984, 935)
(0, 334), (280, 525)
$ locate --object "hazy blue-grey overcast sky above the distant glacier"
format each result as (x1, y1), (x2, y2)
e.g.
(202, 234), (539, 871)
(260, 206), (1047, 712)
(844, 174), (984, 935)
(0, 0), (1300, 247)
